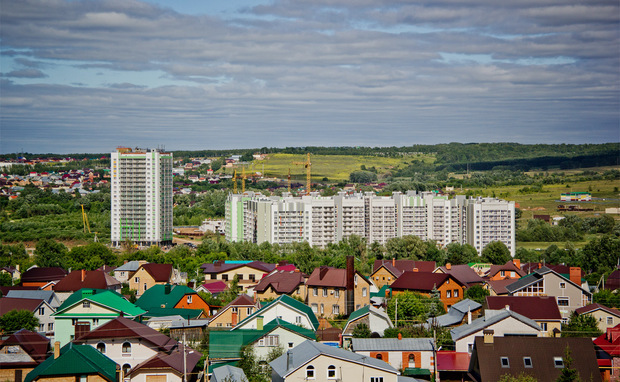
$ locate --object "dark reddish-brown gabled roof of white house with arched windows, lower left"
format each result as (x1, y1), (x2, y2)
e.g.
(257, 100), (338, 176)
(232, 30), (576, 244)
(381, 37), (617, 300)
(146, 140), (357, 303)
(74, 317), (179, 352)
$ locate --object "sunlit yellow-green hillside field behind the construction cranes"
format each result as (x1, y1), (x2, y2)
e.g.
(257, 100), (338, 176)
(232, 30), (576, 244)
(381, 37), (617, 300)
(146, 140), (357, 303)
(255, 154), (435, 182)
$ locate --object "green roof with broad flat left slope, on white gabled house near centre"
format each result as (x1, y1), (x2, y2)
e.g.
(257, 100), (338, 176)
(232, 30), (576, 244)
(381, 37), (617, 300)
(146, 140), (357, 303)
(209, 318), (316, 358)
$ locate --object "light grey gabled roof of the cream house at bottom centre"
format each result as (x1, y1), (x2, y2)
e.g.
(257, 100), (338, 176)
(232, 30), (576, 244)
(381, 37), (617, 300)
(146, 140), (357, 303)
(269, 340), (398, 377)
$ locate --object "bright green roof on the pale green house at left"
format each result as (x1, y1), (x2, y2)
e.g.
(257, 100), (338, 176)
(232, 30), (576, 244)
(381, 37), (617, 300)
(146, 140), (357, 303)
(53, 288), (145, 317)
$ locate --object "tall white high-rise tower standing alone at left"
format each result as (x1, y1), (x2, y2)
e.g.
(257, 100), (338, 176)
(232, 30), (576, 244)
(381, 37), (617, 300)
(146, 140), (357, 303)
(110, 147), (172, 247)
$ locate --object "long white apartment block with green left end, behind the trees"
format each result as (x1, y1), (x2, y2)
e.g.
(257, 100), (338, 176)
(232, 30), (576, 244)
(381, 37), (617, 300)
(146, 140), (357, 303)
(226, 191), (515, 256)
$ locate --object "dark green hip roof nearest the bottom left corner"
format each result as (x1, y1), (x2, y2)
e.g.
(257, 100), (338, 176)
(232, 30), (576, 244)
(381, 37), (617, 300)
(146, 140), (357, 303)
(24, 342), (116, 382)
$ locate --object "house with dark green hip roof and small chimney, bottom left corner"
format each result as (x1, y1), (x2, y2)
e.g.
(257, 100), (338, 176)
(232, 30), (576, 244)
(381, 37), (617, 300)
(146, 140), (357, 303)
(24, 342), (118, 382)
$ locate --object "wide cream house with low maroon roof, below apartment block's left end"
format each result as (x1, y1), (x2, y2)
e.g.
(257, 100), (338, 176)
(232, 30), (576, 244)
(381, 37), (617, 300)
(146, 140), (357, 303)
(200, 260), (276, 291)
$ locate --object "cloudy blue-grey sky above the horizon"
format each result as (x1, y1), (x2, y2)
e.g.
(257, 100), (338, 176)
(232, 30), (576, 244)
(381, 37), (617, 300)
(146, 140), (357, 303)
(0, 0), (620, 154)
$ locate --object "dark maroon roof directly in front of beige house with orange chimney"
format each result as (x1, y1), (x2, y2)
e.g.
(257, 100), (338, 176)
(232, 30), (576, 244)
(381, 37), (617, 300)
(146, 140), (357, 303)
(487, 296), (562, 321)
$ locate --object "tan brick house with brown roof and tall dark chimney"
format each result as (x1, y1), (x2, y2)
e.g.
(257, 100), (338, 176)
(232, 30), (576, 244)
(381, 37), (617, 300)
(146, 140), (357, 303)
(306, 257), (371, 318)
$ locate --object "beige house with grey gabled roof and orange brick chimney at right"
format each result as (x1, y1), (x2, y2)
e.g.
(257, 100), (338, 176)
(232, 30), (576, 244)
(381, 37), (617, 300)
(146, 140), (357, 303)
(506, 266), (592, 322)
